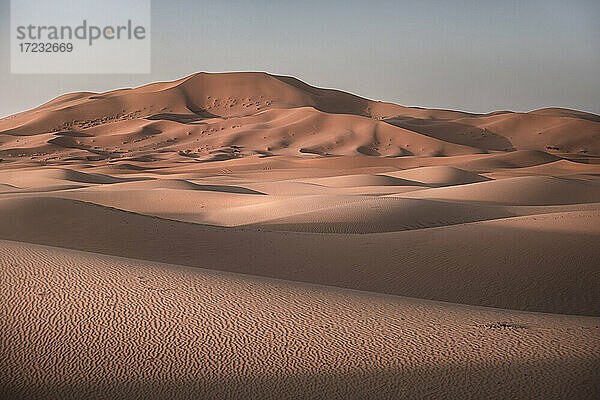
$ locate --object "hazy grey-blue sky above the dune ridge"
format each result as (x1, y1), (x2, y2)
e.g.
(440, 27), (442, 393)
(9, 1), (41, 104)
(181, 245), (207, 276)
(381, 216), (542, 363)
(0, 0), (600, 115)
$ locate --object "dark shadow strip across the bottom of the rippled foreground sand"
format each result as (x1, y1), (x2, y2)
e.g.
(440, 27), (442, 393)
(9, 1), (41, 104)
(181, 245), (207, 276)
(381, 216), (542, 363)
(0, 354), (600, 400)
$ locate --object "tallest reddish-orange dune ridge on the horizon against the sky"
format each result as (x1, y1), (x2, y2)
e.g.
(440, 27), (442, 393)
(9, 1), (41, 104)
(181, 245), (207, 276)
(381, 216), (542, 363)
(0, 73), (600, 163)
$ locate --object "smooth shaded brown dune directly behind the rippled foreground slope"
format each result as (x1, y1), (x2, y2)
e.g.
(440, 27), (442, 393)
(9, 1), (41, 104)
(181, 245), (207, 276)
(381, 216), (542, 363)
(0, 196), (600, 315)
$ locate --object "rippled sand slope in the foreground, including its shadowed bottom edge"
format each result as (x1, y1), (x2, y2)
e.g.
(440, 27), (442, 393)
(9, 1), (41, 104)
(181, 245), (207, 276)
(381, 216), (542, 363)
(0, 241), (600, 399)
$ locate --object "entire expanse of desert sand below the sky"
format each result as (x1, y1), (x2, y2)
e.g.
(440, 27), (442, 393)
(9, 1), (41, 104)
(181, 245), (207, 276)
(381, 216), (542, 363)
(0, 73), (600, 399)
